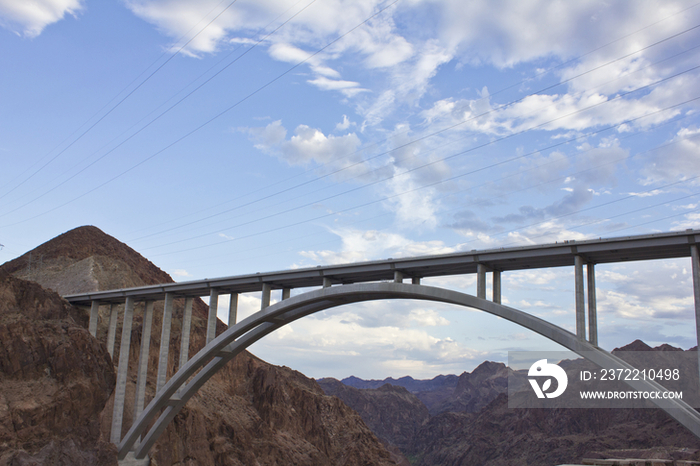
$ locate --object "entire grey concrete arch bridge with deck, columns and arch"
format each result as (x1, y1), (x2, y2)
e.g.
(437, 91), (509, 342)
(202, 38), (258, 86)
(64, 230), (700, 459)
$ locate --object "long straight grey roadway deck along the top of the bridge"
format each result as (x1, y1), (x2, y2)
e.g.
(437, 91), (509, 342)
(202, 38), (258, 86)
(64, 230), (700, 305)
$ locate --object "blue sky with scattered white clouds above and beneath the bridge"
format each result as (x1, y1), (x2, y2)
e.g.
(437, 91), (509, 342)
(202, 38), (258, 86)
(0, 0), (700, 378)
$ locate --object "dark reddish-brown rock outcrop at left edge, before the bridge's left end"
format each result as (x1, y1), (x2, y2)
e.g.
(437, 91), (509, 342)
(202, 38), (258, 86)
(0, 272), (117, 466)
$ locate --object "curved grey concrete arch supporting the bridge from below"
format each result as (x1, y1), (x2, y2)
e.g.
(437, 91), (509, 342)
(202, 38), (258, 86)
(118, 283), (700, 459)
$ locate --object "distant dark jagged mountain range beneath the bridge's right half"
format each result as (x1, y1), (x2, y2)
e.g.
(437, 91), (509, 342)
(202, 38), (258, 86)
(318, 340), (700, 466)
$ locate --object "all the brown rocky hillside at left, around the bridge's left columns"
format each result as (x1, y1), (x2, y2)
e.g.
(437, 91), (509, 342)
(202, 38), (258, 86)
(0, 227), (395, 466)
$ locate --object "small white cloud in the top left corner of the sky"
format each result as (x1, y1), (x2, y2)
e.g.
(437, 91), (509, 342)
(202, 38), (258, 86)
(0, 0), (83, 37)
